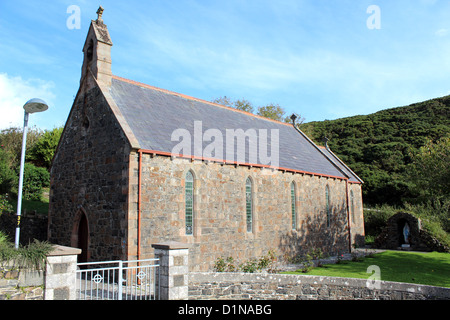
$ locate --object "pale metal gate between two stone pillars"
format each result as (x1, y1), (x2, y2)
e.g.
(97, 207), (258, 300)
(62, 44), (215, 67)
(77, 259), (160, 300)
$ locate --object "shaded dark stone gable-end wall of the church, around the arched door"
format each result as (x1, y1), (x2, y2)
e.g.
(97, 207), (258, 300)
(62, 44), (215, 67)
(48, 82), (130, 261)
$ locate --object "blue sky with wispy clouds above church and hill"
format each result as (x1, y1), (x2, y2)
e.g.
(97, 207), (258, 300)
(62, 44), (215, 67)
(0, 0), (450, 129)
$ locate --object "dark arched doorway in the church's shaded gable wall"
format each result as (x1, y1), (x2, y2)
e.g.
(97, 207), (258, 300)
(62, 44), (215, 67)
(71, 209), (90, 262)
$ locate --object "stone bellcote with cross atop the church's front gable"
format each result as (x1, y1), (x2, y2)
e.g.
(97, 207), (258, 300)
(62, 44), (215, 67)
(81, 7), (113, 88)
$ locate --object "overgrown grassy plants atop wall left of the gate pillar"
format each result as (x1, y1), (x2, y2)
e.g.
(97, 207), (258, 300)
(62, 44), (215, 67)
(0, 231), (52, 270)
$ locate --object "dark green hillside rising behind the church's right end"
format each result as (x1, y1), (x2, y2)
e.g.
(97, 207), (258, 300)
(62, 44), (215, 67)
(300, 96), (450, 205)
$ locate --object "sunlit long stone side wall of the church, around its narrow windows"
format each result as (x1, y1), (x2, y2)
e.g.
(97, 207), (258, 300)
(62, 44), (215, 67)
(129, 154), (362, 271)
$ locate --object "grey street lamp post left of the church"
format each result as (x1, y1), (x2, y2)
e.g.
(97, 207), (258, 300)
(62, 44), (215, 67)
(14, 99), (48, 249)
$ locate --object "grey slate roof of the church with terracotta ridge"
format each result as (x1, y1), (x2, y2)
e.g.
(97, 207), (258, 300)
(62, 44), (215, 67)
(109, 76), (361, 182)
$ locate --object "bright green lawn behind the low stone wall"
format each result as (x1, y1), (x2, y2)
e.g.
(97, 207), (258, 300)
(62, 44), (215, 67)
(289, 251), (450, 288)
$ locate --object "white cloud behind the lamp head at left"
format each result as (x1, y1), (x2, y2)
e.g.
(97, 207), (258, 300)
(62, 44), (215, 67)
(0, 73), (55, 129)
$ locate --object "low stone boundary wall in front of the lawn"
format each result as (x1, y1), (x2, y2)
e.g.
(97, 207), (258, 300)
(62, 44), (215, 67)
(189, 273), (450, 300)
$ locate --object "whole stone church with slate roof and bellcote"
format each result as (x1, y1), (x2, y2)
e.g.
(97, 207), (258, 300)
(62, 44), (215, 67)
(48, 8), (364, 271)
